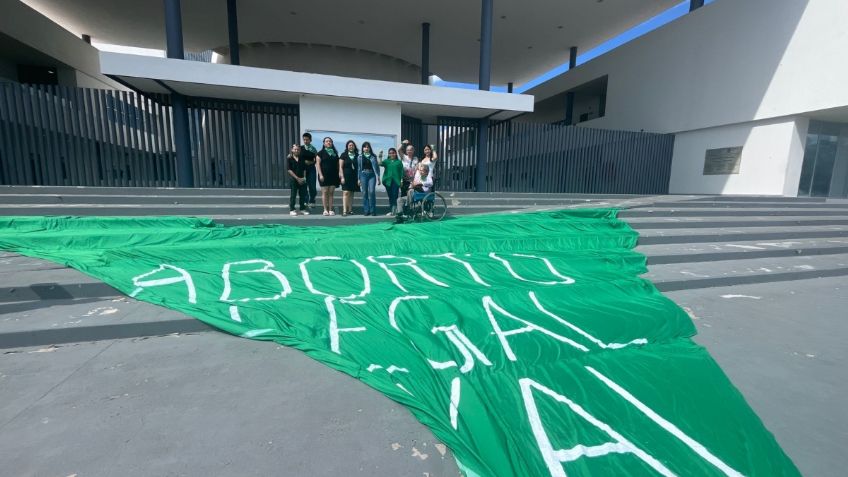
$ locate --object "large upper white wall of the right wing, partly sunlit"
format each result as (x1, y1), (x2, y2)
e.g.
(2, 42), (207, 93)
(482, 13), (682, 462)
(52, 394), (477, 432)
(528, 0), (848, 132)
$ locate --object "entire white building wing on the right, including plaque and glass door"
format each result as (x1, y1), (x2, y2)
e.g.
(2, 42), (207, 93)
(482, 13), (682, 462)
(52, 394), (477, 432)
(523, 0), (848, 197)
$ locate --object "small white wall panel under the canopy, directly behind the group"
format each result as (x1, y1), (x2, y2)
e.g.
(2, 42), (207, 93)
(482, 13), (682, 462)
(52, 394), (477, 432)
(300, 95), (401, 150)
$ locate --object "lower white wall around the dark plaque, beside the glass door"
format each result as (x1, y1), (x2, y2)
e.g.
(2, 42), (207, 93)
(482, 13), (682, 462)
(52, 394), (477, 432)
(669, 117), (809, 197)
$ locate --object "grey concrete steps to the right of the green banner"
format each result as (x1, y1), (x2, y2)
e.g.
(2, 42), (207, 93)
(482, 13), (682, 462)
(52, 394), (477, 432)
(619, 197), (848, 291)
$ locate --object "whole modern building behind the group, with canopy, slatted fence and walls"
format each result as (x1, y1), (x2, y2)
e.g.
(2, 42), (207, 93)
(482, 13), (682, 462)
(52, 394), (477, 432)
(0, 0), (848, 197)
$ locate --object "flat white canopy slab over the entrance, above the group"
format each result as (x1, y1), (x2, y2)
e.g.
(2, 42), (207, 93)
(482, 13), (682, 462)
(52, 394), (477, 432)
(100, 52), (533, 119)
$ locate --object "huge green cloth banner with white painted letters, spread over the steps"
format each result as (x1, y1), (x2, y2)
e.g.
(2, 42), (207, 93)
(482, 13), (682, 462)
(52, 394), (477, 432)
(0, 209), (799, 477)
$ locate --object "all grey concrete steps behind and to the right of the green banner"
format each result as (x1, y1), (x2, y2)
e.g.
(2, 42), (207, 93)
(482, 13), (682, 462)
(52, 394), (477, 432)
(0, 186), (848, 289)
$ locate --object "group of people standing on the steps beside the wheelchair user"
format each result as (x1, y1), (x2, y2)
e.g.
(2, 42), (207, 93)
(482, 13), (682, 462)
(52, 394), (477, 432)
(287, 133), (438, 216)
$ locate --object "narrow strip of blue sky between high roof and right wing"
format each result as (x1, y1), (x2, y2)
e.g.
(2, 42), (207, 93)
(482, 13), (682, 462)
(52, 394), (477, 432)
(433, 0), (715, 93)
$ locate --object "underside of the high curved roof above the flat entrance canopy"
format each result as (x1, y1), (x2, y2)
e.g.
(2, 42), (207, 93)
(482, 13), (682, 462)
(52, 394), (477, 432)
(24, 0), (680, 84)
